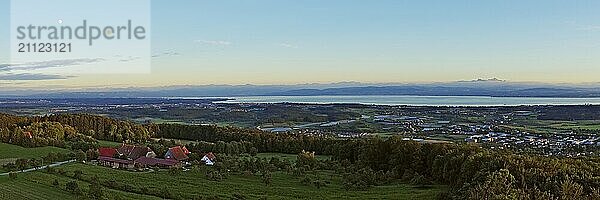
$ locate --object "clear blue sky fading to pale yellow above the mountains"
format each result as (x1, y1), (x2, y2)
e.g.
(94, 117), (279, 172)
(0, 0), (600, 88)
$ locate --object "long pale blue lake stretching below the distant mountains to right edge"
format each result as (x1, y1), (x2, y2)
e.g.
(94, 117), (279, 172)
(216, 96), (600, 106)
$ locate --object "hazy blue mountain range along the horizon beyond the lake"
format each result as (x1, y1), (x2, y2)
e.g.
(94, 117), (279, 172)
(0, 79), (600, 98)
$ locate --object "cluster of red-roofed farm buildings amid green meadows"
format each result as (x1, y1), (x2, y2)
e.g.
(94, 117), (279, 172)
(92, 144), (216, 170)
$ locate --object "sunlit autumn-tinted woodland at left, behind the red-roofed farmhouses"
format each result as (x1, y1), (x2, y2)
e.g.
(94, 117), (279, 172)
(0, 114), (156, 150)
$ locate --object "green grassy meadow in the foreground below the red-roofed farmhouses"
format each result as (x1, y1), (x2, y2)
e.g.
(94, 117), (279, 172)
(0, 164), (446, 199)
